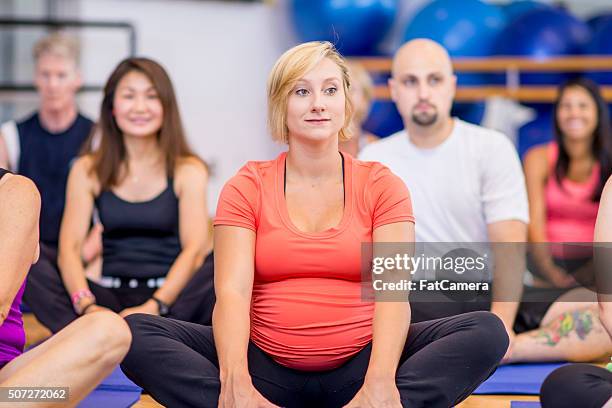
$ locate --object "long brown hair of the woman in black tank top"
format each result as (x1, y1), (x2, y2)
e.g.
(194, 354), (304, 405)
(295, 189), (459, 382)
(91, 58), (201, 190)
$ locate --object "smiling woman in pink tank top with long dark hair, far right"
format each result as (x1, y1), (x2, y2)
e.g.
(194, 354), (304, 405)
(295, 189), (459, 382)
(525, 78), (612, 287)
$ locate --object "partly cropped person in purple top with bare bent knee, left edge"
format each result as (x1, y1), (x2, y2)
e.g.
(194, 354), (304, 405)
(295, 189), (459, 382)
(0, 169), (131, 407)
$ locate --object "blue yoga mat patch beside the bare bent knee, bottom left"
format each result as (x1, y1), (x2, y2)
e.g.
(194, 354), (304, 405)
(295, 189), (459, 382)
(79, 367), (142, 408)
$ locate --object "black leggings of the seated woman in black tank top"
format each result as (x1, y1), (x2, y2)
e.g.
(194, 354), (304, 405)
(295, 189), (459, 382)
(23, 244), (215, 333)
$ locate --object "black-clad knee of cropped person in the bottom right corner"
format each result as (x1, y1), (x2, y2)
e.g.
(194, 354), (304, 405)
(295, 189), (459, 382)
(540, 364), (612, 408)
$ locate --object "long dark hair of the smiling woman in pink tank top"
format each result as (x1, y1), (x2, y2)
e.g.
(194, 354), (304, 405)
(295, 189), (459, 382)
(553, 78), (612, 202)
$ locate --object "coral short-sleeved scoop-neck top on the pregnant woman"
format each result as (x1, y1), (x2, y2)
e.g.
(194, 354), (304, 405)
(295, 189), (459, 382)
(214, 153), (414, 371)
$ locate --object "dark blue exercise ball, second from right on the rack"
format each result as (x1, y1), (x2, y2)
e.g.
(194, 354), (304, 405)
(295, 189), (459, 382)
(495, 7), (591, 85)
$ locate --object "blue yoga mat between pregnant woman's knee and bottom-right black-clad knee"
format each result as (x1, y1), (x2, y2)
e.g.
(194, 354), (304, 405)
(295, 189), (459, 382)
(474, 363), (565, 395)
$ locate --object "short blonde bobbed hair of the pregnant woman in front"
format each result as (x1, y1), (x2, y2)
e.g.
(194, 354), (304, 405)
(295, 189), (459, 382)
(268, 41), (353, 143)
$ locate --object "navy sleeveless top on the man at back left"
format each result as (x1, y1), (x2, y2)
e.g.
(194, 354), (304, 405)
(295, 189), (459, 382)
(17, 113), (93, 246)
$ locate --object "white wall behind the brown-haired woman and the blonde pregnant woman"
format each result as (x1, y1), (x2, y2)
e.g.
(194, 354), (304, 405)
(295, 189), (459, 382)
(78, 0), (293, 212)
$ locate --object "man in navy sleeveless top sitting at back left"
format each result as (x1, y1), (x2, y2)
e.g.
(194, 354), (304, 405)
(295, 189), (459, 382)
(0, 33), (100, 332)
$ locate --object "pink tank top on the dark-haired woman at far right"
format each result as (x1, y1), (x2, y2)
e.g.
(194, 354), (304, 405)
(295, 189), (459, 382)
(544, 142), (600, 258)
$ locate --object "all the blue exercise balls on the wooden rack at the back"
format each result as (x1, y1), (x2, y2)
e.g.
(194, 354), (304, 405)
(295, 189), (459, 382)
(290, 0), (612, 143)
